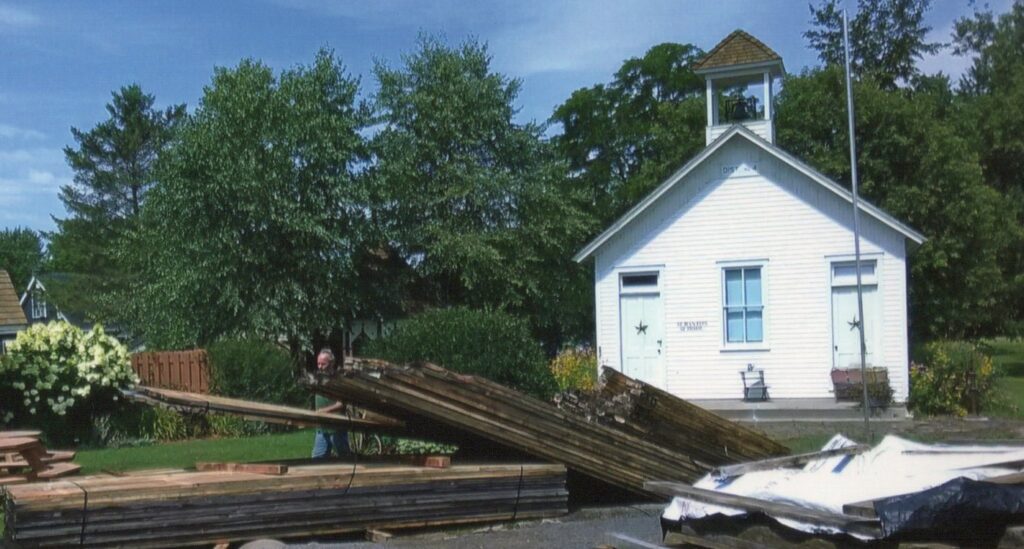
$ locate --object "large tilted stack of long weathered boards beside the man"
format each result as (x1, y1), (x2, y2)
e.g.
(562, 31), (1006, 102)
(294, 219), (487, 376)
(307, 358), (729, 496)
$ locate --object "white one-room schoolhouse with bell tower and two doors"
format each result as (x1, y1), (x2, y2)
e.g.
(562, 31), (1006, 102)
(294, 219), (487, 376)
(574, 31), (925, 402)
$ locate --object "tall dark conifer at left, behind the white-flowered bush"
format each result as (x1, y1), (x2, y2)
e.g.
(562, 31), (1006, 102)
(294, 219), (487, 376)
(47, 84), (186, 321)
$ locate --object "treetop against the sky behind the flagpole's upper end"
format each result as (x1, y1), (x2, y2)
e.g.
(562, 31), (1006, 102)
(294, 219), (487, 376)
(804, 0), (942, 88)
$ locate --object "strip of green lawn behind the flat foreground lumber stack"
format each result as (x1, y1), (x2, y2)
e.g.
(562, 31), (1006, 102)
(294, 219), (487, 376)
(75, 430), (313, 474)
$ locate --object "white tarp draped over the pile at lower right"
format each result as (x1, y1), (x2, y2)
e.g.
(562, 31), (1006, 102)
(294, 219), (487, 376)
(662, 434), (1024, 533)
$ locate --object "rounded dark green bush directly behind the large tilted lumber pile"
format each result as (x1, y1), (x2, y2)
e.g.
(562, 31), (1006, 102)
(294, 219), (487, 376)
(367, 307), (555, 399)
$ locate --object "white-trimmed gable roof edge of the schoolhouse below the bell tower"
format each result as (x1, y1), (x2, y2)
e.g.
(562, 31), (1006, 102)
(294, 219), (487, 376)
(572, 124), (928, 262)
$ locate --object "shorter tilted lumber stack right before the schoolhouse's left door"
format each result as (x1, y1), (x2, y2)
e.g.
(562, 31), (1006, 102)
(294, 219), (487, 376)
(555, 368), (788, 466)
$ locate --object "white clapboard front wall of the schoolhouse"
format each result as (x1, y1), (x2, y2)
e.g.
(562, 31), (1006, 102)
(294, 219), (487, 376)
(595, 138), (908, 402)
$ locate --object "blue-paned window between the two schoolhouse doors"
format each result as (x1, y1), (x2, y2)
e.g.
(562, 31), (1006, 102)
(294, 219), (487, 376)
(722, 265), (765, 345)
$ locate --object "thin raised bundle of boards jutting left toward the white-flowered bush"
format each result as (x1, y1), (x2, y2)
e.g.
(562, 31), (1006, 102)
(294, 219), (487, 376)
(122, 385), (402, 432)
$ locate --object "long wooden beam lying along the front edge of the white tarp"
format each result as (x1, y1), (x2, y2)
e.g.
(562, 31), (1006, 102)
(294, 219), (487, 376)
(644, 480), (882, 538)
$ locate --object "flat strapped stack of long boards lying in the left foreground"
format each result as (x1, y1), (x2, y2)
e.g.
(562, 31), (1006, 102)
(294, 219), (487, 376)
(0, 463), (567, 547)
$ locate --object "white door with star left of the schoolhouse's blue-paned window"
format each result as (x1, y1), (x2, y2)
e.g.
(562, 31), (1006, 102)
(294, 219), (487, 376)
(620, 294), (665, 387)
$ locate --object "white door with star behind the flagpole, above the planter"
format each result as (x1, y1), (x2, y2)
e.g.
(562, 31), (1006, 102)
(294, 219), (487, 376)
(831, 286), (879, 368)
